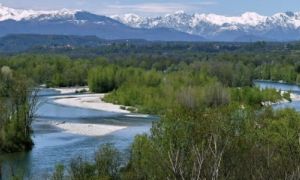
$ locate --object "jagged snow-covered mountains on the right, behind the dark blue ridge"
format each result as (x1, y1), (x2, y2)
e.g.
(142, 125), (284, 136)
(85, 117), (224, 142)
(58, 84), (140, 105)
(112, 11), (300, 41)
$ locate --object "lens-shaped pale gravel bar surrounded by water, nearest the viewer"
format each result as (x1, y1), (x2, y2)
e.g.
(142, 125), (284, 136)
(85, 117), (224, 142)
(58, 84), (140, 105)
(51, 123), (127, 136)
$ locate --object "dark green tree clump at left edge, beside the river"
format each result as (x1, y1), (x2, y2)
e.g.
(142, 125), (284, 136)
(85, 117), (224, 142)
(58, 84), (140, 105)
(0, 66), (37, 153)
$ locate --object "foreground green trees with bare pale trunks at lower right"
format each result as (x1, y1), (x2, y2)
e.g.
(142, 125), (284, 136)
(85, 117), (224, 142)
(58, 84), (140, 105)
(121, 106), (300, 179)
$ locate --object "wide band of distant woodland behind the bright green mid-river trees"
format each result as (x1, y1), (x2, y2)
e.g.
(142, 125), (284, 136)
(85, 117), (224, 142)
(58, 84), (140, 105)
(0, 50), (300, 87)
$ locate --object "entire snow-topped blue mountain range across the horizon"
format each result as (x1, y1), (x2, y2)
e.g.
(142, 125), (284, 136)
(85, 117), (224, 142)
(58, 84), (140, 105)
(0, 5), (300, 42)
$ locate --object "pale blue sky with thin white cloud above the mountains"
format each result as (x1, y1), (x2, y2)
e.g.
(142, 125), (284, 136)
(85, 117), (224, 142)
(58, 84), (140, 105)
(0, 0), (300, 16)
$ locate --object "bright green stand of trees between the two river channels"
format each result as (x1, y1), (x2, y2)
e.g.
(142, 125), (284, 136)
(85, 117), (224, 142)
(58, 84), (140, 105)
(88, 61), (289, 114)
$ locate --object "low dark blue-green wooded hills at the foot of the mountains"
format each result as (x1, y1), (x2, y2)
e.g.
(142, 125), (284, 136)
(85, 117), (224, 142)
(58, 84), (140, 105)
(0, 34), (290, 54)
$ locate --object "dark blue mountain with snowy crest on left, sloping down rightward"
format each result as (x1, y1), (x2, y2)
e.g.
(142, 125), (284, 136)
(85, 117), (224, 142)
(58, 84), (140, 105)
(0, 5), (203, 41)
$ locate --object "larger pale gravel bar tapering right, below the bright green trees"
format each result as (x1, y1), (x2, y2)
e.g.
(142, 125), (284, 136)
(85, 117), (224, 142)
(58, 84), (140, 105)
(53, 94), (130, 113)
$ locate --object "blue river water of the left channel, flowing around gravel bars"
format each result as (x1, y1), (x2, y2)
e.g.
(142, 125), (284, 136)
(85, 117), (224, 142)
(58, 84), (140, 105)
(0, 90), (158, 179)
